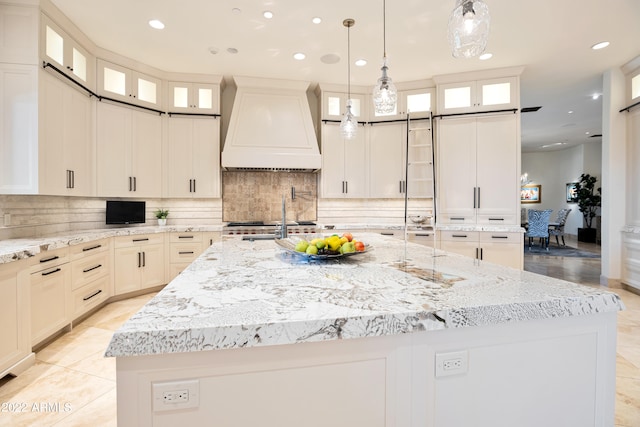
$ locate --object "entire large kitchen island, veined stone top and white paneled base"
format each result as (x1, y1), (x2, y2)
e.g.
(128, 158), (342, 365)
(106, 233), (623, 427)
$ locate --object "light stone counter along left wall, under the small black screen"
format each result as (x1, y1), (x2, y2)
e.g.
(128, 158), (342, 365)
(0, 225), (222, 264)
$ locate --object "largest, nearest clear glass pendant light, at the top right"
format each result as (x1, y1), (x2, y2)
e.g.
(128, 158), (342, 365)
(448, 0), (490, 58)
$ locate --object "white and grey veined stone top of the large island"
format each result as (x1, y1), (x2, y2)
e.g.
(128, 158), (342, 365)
(106, 233), (624, 357)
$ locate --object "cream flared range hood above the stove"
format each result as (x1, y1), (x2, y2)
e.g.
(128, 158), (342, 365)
(222, 77), (322, 172)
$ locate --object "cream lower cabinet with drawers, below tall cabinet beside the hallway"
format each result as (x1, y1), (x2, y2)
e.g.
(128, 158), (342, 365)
(439, 231), (524, 269)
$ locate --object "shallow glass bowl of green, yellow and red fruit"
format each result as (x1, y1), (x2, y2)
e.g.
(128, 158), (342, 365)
(275, 233), (371, 259)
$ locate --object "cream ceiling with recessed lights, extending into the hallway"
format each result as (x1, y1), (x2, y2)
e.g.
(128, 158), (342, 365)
(51, 0), (640, 151)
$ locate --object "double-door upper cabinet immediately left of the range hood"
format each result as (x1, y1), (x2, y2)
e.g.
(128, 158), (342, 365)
(165, 117), (221, 198)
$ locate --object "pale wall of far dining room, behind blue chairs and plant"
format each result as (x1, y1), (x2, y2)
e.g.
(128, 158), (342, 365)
(521, 141), (602, 235)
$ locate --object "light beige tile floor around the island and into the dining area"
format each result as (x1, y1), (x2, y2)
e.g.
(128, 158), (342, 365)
(0, 240), (640, 427)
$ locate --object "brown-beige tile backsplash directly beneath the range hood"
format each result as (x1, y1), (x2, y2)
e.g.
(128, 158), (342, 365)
(222, 171), (318, 221)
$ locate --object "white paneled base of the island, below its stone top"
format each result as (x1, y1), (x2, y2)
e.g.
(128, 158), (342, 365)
(117, 313), (616, 427)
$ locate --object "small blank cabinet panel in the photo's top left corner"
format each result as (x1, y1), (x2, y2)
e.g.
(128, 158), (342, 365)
(0, 4), (40, 65)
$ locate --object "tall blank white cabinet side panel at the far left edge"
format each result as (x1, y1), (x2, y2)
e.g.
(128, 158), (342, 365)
(0, 63), (38, 194)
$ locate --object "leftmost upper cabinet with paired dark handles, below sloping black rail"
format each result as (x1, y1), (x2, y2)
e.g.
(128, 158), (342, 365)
(38, 72), (95, 196)
